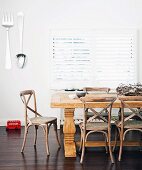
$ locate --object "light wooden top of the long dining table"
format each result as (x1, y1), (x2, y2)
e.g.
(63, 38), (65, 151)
(50, 93), (142, 108)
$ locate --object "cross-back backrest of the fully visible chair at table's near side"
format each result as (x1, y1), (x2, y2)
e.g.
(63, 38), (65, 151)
(80, 97), (116, 127)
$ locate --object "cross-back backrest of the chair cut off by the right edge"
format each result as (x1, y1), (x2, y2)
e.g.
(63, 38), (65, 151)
(119, 96), (142, 126)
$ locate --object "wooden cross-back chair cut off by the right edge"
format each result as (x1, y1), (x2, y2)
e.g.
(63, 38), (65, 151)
(114, 96), (142, 161)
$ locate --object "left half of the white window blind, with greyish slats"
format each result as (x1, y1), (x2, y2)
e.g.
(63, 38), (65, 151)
(52, 36), (90, 81)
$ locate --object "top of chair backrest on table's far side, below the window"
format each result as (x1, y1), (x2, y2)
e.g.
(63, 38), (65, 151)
(83, 87), (110, 93)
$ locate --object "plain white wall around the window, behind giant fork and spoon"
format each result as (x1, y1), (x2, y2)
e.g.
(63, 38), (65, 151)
(0, 0), (142, 125)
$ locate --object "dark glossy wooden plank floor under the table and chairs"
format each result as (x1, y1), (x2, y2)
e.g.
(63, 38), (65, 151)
(0, 127), (142, 170)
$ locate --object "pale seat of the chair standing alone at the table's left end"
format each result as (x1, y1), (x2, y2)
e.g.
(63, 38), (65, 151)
(30, 117), (57, 124)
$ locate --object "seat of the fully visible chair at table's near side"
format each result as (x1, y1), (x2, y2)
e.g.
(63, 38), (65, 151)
(79, 122), (108, 131)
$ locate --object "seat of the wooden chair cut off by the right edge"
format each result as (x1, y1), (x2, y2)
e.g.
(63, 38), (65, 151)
(115, 120), (142, 129)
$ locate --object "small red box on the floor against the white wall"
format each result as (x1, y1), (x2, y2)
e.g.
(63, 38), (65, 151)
(6, 120), (21, 130)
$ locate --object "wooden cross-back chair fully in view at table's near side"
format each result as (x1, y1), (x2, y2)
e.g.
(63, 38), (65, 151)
(79, 97), (116, 163)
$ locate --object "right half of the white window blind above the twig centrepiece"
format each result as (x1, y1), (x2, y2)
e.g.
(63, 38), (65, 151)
(94, 30), (137, 87)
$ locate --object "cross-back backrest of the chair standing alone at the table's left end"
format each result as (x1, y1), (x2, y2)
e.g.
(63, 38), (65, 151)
(20, 90), (41, 123)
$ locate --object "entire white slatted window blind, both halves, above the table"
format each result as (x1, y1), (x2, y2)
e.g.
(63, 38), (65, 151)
(50, 29), (137, 88)
